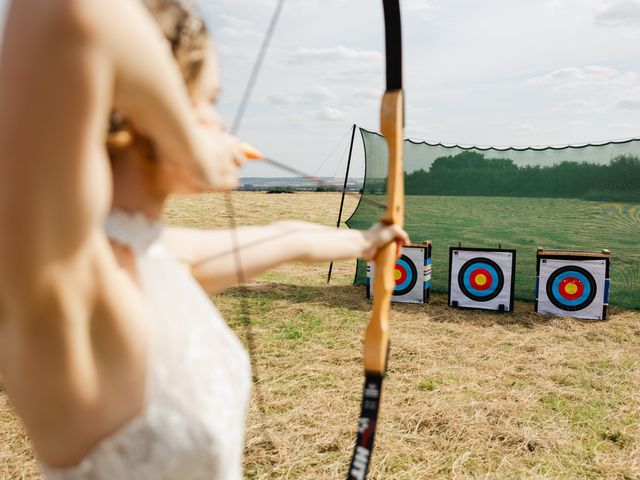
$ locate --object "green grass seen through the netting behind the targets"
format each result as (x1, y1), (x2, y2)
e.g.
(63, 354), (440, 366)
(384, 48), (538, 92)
(349, 196), (640, 308)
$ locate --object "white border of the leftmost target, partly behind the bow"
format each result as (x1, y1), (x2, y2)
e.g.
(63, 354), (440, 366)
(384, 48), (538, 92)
(367, 242), (431, 303)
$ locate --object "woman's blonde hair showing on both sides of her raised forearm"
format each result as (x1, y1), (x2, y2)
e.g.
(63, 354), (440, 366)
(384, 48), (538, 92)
(107, 0), (210, 157)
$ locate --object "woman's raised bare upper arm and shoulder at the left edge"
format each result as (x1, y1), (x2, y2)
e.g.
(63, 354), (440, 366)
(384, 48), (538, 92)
(0, 0), (113, 288)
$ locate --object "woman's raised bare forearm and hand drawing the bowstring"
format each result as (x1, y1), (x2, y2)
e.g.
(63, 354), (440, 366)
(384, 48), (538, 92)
(90, 0), (241, 190)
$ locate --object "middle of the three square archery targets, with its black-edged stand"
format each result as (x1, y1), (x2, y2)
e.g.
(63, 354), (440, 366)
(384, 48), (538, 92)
(449, 247), (516, 312)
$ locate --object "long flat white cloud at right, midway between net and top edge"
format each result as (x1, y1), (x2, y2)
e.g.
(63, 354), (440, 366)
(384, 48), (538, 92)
(527, 65), (638, 90)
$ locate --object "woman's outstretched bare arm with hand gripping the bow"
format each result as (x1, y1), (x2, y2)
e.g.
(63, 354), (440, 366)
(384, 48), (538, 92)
(162, 221), (409, 293)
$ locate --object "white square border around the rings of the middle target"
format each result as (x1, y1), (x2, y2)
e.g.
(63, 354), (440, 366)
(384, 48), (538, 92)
(447, 247), (516, 312)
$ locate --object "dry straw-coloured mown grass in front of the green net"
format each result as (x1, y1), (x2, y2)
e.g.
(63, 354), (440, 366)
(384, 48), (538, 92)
(0, 193), (640, 480)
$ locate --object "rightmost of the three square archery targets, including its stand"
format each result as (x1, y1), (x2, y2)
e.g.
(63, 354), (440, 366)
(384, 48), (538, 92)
(535, 248), (611, 320)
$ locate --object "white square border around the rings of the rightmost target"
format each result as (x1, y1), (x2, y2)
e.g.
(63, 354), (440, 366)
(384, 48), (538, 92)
(535, 255), (610, 320)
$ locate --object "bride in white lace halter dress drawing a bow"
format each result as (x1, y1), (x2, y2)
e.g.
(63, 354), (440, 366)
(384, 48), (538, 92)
(0, 0), (408, 480)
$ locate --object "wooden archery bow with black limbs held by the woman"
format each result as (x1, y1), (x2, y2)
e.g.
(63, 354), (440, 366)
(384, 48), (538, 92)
(347, 0), (404, 480)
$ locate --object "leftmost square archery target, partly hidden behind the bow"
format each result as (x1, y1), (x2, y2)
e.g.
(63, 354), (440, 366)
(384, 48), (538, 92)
(367, 242), (431, 303)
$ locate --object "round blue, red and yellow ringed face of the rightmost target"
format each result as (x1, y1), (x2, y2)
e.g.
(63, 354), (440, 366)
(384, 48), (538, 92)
(547, 266), (597, 312)
